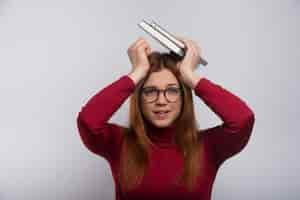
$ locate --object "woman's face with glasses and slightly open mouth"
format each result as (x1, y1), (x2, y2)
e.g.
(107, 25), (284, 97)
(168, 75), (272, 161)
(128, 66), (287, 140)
(141, 69), (182, 128)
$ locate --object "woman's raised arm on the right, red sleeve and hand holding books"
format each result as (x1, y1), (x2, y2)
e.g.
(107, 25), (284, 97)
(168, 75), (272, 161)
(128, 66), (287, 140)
(177, 37), (255, 165)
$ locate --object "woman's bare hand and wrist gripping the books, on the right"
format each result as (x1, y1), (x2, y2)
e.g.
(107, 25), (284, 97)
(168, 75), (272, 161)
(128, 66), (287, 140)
(175, 36), (201, 88)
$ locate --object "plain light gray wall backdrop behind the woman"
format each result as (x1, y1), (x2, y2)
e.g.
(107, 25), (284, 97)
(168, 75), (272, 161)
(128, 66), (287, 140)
(0, 0), (300, 200)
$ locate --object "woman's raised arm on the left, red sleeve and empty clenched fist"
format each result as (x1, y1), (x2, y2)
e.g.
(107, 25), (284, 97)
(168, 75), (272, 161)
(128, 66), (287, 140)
(77, 38), (151, 161)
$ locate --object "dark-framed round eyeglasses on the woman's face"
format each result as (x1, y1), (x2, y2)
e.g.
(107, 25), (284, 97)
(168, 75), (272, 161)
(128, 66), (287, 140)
(141, 87), (182, 103)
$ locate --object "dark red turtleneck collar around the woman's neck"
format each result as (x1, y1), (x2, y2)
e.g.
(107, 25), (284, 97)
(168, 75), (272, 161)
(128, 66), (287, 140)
(145, 119), (175, 148)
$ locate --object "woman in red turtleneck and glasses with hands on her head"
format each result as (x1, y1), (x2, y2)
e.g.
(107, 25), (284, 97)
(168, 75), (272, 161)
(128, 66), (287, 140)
(77, 37), (255, 200)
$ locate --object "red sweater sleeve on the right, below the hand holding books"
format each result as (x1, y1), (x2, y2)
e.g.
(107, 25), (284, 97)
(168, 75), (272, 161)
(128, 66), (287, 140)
(194, 78), (255, 165)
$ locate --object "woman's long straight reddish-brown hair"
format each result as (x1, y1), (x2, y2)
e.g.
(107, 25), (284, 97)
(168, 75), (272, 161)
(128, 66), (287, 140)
(119, 51), (201, 190)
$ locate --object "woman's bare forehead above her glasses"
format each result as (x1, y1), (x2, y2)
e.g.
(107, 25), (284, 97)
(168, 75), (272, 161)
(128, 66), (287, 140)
(144, 69), (179, 87)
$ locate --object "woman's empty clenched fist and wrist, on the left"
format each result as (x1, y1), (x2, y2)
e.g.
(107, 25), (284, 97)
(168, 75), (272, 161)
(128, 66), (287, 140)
(127, 38), (151, 84)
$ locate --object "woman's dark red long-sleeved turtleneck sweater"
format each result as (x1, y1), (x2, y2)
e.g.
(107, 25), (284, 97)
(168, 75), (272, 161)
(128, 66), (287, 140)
(77, 75), (255, 200)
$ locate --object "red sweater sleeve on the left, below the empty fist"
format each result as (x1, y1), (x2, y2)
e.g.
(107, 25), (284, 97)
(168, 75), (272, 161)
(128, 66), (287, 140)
(77, 75), (135, 161)
